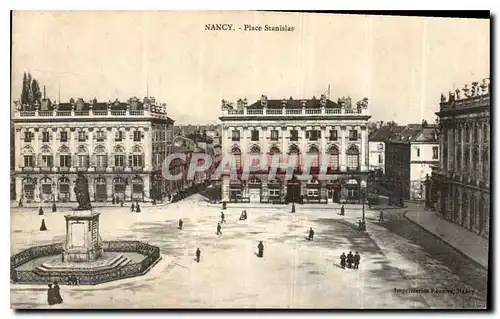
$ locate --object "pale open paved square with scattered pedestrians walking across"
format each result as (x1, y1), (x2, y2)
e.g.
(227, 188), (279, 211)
(11, 195), (487, 309)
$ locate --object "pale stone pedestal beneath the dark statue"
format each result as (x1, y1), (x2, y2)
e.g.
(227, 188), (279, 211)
(62, 210), (103, 262)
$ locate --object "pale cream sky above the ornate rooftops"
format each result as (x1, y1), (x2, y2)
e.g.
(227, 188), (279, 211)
(12, 11), (490, 124)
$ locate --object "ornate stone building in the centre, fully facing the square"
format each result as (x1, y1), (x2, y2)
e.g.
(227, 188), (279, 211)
(220, 95), (370, 203)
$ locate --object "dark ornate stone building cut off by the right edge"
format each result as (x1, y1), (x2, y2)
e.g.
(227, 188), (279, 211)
(428, 80), (491, 237)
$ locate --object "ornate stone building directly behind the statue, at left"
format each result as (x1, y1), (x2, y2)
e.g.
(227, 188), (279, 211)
(13, 98), (174, 202)
